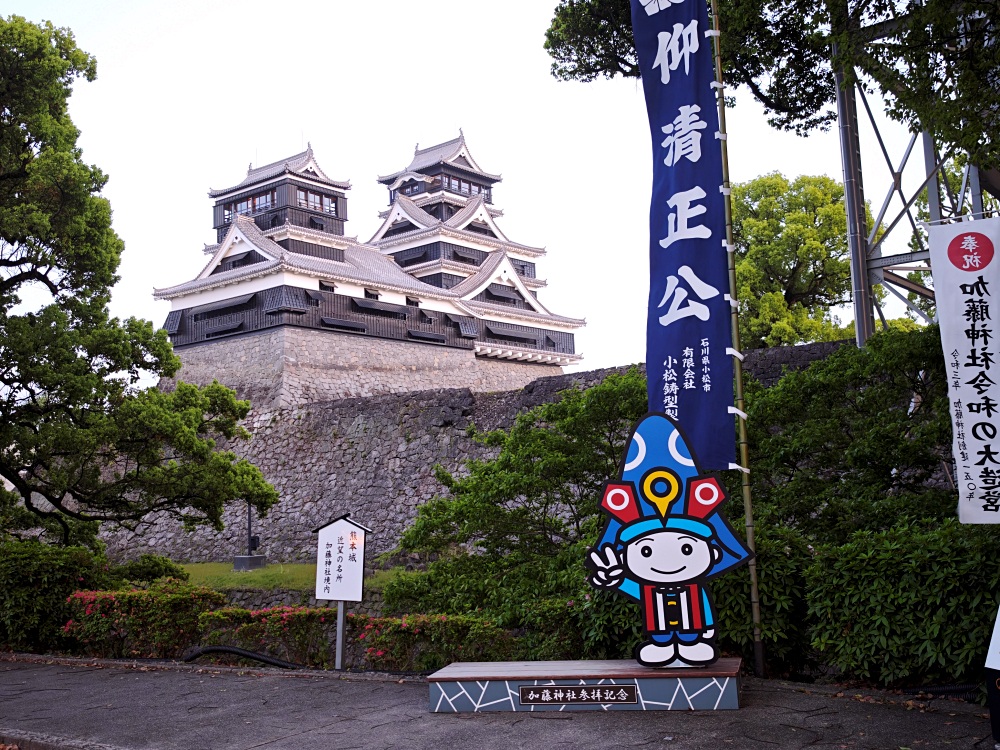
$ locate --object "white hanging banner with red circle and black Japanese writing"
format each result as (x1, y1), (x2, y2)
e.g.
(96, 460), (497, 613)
(928, 218), (1000, 523)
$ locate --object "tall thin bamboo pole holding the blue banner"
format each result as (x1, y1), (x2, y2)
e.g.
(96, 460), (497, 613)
(711, 0), (764, 677)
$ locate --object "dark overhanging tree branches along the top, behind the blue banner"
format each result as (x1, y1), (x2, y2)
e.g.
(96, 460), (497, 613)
(545, 0), (1000, 167)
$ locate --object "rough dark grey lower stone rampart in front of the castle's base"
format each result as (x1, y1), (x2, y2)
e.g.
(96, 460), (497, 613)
(103, 344), (852, 562)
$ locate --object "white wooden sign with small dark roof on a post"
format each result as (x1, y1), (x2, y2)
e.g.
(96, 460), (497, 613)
(313, 513), (371, 670)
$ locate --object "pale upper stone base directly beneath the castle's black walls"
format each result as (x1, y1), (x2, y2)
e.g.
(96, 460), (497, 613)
(168, 326), (562, 410)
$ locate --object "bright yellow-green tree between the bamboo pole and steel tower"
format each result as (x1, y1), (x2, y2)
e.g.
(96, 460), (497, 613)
(732, 172), (851, 349)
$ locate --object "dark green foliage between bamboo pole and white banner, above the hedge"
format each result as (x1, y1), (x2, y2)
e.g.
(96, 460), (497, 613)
(747, 326), (957, 544)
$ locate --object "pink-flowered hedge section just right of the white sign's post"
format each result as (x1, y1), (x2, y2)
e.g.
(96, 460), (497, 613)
(347, 614), (517, 672)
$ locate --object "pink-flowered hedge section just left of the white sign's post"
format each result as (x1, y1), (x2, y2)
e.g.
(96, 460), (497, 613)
(198, 607), (337, 669)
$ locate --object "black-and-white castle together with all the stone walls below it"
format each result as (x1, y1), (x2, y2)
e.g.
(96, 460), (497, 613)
(103, 136), (831, 562)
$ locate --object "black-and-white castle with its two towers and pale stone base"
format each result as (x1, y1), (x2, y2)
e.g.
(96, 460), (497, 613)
(155, 136), (584, 407)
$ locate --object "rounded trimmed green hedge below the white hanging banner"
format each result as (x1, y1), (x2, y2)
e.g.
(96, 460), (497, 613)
(806, 520), (1000, 685)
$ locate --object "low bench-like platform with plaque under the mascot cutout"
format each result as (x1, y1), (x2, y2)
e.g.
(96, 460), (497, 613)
(427, 659), (743, 713)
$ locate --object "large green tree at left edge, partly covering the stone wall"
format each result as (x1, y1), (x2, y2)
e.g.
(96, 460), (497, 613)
(0, 16), (277, 543)
